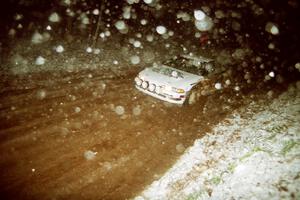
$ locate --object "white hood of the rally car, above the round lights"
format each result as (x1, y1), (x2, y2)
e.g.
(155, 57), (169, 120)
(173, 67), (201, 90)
(139, 65), (204, 89)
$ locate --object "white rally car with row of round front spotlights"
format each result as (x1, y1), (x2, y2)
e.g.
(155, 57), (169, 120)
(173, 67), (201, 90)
(135, 55), (213, 104)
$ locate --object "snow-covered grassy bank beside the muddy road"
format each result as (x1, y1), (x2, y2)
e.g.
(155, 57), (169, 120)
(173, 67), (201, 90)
(135, 81), (300, 200)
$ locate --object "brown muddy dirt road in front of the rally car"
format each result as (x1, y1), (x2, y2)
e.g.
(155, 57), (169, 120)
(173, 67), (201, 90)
(0, 70), (237, 200)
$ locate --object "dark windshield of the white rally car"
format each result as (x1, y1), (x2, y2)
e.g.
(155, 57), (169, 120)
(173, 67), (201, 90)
(163, 56), (212, 76)
